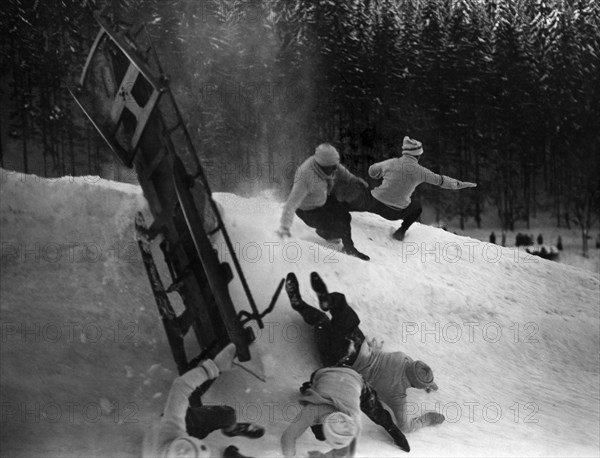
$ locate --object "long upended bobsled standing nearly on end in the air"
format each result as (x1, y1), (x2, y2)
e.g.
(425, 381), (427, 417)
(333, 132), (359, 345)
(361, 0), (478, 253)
(69, 16), (284, 373)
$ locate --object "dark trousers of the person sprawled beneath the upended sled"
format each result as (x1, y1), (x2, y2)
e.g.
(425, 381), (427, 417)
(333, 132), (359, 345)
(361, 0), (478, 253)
(185, 380), (237, 439)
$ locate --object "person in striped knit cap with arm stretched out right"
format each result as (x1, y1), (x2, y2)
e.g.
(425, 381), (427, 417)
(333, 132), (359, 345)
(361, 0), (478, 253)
(366, 137), (477, 240)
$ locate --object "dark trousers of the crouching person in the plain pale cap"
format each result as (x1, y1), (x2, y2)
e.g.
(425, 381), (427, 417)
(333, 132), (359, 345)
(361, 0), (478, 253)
(296, 195), (354, 247)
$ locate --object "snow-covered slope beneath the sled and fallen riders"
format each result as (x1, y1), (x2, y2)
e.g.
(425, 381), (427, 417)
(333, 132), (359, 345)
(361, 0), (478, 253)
(0, 170), (600, 457)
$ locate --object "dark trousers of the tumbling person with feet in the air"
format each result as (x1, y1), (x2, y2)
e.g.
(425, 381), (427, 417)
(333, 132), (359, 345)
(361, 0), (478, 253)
(296, 293), (365, 366)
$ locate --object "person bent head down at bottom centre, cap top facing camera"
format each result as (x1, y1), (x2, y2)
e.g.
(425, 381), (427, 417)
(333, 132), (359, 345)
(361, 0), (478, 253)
(281, 367), (410, 457)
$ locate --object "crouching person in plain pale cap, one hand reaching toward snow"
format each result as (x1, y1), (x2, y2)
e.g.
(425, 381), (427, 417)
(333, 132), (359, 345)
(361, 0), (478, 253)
(277, 143), (369, 261)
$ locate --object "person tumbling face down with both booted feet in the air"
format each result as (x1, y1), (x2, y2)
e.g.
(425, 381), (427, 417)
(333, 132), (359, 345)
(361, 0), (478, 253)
(285, 272), (444, 433)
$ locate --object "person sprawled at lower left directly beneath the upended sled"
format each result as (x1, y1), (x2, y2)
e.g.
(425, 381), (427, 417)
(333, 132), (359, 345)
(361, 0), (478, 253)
(142, 344), (265, 458)
